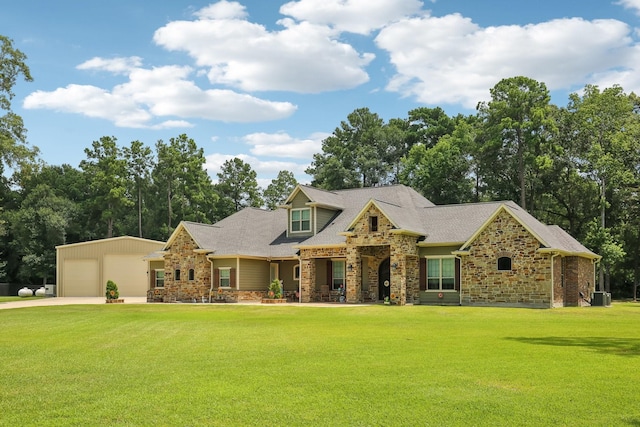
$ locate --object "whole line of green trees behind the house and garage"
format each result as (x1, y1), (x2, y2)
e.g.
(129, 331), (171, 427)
(0, 36), (640, 296)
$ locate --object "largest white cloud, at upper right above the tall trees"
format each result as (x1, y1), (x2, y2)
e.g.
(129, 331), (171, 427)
(376, 14), (640, 108)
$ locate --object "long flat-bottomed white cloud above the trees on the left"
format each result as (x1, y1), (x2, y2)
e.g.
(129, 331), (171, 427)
(24, 58), (296, 129)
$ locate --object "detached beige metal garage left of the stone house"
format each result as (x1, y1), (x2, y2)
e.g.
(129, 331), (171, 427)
(56, 236), (165, 298)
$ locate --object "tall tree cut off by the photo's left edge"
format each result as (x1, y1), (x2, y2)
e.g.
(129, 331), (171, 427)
(0, 35), (38, 173)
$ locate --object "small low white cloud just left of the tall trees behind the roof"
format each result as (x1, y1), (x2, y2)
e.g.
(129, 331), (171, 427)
(243, 132), (330, 159)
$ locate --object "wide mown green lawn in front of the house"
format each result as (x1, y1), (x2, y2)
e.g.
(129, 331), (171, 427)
(0, 303), (640, 426)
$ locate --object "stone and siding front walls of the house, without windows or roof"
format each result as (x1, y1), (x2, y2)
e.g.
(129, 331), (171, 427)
(154, 189), (594, 308)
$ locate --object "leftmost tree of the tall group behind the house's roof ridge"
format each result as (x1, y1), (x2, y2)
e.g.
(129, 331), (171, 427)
(306, 108), (391, 190)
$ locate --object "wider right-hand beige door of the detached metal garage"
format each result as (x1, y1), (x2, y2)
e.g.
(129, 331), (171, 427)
(103, 254), (148, 298)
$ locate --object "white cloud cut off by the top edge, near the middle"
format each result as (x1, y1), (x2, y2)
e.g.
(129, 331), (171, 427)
(280, 0), (422, 35)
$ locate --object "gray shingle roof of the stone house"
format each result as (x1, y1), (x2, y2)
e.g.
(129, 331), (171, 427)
(169, 185), (596, 258)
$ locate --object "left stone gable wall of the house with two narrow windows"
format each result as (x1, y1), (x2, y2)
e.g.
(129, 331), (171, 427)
(164, 229), (211, 301)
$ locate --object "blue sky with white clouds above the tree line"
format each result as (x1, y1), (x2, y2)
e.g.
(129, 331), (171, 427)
(0, 0), (640, 188)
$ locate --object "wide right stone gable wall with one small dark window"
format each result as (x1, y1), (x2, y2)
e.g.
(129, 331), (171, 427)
(461, 211), (552, 308)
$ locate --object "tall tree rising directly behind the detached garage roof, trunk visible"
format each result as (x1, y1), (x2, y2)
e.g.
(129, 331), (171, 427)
(80, 136), (133, 238)
